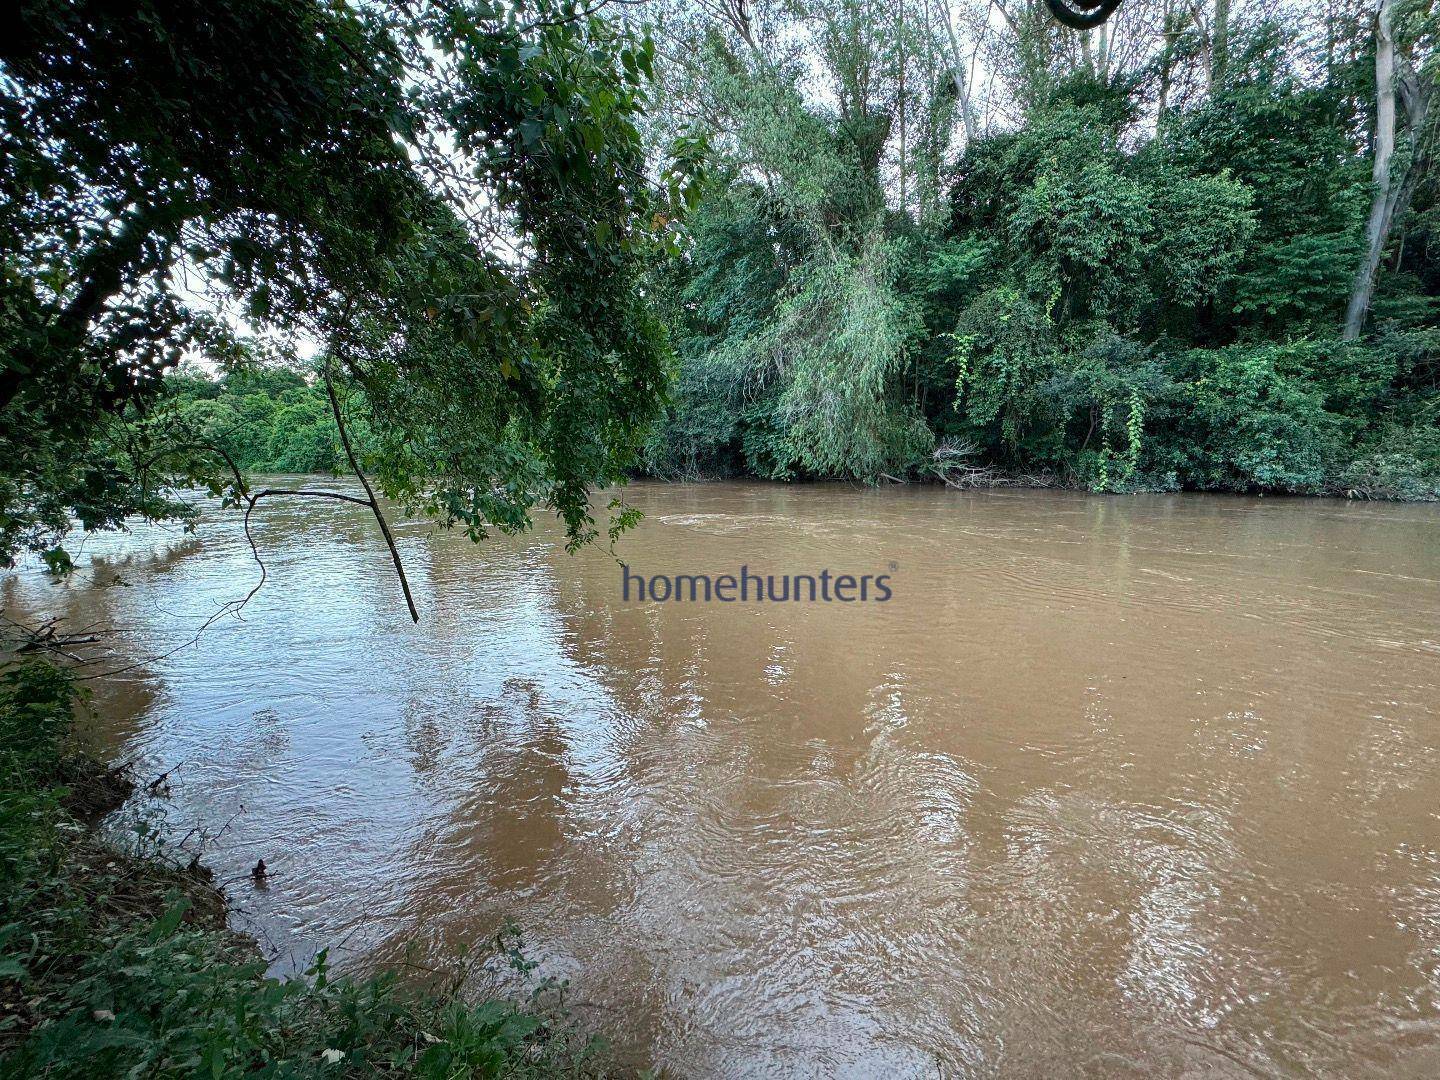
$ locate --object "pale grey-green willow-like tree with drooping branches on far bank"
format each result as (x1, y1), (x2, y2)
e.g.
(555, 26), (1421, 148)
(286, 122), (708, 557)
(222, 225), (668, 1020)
(639, 0), (933, 480)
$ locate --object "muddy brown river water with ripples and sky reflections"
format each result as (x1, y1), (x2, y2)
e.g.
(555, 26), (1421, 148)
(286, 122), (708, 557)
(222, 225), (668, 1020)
(0, 484), (1440, 1077)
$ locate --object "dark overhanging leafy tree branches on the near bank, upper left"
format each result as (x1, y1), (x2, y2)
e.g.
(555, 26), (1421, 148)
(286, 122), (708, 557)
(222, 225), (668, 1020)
(0, 0), (696, 567)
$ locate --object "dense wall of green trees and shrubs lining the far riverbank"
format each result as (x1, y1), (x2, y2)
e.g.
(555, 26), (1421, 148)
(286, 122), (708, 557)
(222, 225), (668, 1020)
(648, 0), (1440, 497)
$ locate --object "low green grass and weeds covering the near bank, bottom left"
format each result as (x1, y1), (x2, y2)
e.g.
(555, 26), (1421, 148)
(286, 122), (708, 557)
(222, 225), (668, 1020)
(0, 660), (603, 1079)
